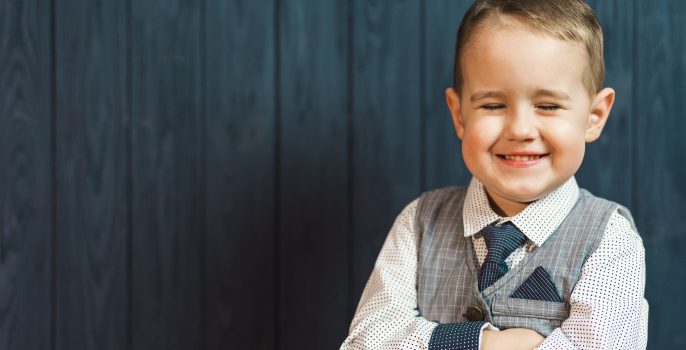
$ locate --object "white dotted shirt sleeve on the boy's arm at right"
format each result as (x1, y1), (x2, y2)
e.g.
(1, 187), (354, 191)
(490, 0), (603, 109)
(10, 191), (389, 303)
(536, 212), (648, 350)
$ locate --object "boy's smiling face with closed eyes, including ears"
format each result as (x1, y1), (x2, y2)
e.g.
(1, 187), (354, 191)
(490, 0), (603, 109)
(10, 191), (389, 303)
(446, 17), (614, 216)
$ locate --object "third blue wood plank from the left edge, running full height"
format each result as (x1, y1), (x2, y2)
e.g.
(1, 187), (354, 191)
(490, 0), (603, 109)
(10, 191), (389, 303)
(131, 0), (205, 349)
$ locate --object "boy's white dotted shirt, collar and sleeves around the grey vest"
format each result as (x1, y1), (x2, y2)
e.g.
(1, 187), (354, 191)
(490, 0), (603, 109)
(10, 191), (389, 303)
(341, 177), (648, 350)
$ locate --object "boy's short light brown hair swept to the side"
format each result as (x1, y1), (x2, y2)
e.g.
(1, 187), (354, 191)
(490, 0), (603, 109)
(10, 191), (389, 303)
(453, 0), (605, 95)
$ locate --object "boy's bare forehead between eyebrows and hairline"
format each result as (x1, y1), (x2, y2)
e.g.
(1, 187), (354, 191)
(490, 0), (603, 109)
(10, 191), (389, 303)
(460, 18), (588, 93)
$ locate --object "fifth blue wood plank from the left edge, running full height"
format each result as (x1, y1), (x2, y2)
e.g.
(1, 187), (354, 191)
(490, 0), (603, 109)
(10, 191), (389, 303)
(278, 0), (350, 349)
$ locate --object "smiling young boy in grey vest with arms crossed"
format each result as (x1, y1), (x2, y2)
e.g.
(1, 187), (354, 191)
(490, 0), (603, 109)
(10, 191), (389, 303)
(341, 0), (648, 350)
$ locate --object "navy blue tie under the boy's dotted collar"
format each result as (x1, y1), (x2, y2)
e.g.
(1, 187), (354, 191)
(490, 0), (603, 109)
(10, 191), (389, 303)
(479, 221), (526, 291)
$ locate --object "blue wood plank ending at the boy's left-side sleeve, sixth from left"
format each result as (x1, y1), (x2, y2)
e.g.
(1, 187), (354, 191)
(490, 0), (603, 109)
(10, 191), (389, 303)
(352, 0), (422, 305)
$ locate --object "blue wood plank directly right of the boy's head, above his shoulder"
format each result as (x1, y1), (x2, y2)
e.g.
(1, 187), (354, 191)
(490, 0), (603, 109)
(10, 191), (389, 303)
(576, 0), (636, 209)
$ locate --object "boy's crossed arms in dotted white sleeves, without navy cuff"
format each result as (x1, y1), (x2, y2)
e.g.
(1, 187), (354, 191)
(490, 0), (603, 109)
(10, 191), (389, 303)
(341, 202), (647, 350)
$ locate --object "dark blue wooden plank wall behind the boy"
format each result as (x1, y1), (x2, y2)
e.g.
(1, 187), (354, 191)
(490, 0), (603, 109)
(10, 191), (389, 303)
(0, 0), (686, 350)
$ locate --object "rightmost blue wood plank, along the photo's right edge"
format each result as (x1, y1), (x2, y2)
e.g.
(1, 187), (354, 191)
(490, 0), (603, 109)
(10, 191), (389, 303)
(634, 0), (686, 349)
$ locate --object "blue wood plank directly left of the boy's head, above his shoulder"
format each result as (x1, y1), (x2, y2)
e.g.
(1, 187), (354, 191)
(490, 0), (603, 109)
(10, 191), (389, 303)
(422, 0), (472, 190)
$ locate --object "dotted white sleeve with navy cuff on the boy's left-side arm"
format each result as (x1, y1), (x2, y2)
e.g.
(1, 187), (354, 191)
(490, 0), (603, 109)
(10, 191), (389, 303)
(340, 200), (497, 350)
